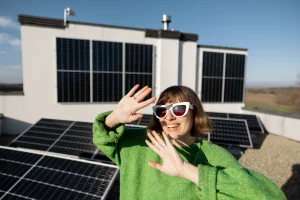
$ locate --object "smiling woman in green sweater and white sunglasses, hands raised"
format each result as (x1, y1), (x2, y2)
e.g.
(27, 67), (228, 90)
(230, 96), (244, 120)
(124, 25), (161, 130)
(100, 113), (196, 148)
(93, 85), (285, 200)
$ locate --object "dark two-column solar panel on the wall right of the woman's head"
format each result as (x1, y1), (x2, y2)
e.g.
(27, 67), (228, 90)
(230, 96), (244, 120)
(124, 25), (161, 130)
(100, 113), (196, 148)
(201, 52), (245, 102)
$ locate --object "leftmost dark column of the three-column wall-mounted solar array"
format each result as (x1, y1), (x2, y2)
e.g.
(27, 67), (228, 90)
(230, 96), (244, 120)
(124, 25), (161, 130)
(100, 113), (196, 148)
(56, 38), (90, 102)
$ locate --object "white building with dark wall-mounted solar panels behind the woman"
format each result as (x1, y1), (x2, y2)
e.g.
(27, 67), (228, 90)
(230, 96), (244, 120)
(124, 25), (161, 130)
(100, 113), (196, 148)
(0, 15), (248, 133)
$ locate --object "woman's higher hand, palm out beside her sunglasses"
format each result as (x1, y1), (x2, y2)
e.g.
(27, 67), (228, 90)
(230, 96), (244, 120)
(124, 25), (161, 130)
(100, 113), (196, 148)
(105, 85), (156, 128)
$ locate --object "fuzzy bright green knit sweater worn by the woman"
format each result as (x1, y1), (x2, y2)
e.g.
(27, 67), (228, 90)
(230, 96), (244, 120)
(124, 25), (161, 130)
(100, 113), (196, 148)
(93, 111), (286, 200)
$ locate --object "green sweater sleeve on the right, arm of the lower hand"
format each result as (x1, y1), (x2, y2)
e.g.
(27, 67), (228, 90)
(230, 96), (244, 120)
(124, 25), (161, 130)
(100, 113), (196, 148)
(198, 141), (286, 200)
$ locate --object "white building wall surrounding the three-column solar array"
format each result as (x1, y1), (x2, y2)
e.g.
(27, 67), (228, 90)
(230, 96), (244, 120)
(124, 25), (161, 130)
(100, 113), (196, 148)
(0, 24), (185, 134)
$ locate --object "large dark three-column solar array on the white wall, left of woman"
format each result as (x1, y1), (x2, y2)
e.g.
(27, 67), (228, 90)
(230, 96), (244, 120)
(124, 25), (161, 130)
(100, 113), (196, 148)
(56, 38), (153, 102)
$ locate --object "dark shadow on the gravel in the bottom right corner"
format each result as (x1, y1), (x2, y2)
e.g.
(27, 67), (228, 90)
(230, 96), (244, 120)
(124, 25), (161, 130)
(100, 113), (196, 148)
(281, 164), (300, 200)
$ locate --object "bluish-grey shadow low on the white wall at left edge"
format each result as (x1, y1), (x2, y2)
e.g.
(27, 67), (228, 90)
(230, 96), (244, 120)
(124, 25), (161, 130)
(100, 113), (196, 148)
(2, 116), (32, 135)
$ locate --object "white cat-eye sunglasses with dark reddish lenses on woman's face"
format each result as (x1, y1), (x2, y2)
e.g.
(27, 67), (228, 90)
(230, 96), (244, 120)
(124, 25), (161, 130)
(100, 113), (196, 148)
(152, 102), (194, 119)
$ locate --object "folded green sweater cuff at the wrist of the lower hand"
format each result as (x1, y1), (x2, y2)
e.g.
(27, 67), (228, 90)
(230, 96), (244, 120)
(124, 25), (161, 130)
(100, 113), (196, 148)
(198, 164), (217, 200)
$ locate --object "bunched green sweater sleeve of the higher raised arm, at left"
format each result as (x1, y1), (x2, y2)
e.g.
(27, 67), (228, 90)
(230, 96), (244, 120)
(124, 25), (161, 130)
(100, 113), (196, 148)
(93, 111), (125, 167)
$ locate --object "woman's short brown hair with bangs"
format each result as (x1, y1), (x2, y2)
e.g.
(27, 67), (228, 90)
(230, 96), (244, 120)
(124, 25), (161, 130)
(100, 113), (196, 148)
(147, 85), (212, 137)
